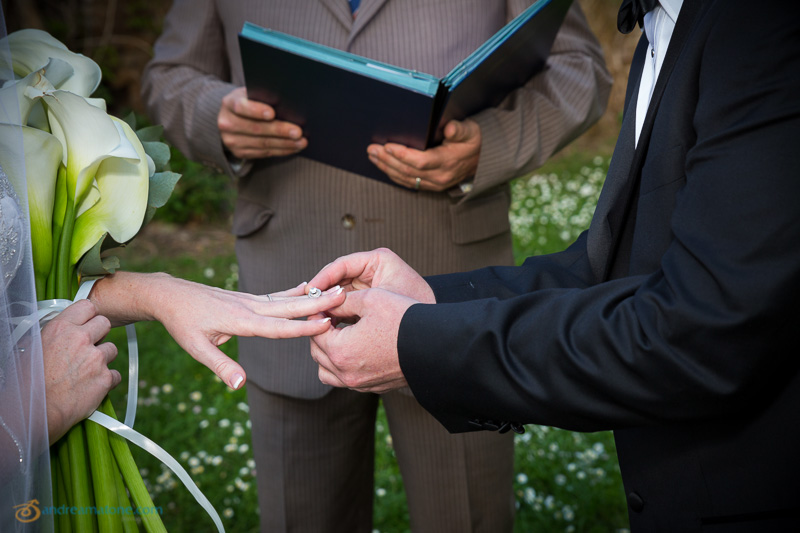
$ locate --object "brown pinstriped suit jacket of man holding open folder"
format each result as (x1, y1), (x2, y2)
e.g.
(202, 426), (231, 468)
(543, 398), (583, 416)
(144, 0), (610, 398)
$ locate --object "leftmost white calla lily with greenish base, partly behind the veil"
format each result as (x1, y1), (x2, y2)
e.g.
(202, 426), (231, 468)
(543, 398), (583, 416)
(0, 124), (61, 296)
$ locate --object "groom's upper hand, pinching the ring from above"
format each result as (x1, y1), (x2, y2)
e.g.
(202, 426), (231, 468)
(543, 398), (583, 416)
(307, 248), (436, 303)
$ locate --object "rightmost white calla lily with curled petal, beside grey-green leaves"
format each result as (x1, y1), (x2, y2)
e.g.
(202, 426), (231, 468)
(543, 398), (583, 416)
(70, 117), (150, 264)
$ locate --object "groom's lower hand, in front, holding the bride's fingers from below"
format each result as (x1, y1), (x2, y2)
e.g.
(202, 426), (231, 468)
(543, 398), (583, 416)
(311, 289), (418, 393)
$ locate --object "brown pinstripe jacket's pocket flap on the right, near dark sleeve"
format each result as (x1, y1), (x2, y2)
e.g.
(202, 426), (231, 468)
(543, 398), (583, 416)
(450, 188), (511, 244)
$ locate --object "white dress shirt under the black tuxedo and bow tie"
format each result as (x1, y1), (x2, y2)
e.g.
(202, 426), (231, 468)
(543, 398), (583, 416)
(634, 0), (683, 146)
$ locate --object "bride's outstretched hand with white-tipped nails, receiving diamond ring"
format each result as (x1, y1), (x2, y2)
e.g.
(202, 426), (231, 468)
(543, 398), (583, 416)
(91, 272), (345, 389)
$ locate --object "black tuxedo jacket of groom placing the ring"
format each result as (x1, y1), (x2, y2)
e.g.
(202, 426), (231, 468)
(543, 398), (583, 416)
(398, 0), (800, 532)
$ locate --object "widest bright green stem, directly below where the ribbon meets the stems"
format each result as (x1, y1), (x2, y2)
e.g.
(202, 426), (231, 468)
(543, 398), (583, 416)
(84, 420), (122, 533)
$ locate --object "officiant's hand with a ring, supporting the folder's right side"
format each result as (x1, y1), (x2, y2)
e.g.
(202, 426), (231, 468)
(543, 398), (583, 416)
(367, 119), (481, 191)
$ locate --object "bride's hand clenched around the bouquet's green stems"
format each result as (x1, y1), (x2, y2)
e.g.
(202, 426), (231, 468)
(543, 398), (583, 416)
(42, 300), (122, 444)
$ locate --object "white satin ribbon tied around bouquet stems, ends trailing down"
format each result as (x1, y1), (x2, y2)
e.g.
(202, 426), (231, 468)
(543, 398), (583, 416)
(11, 279), (225, 533)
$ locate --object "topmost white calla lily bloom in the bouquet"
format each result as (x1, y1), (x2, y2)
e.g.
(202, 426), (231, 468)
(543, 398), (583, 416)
(0, 29), (102, 96)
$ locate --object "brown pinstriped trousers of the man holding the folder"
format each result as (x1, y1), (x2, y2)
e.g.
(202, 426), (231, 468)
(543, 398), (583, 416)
(248, 383), (514, 533)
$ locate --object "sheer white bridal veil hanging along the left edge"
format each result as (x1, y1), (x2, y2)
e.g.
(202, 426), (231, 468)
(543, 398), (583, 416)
(0, 6), (53, 533)
